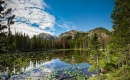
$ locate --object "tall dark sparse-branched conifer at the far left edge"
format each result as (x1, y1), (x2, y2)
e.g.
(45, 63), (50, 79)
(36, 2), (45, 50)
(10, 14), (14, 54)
(0, 0), (15, 52)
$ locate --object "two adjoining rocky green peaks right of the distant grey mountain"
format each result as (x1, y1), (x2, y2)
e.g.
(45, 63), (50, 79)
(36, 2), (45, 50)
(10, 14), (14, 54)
(59, 27), (111, 39)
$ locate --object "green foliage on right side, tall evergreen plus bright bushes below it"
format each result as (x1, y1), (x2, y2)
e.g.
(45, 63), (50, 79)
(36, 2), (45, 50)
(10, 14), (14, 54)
(88, 0), (130, 80)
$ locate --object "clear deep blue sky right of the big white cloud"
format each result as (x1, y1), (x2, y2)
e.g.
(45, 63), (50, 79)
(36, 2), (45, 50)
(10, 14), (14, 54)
(44, 0), (114, 35)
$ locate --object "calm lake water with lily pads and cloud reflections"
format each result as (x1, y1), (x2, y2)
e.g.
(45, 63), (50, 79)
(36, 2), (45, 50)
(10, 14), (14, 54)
(0, 50), (95, 80)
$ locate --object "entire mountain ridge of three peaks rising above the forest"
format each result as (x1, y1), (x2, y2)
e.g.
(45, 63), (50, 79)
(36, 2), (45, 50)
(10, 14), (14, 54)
(37, 27), (111, 40)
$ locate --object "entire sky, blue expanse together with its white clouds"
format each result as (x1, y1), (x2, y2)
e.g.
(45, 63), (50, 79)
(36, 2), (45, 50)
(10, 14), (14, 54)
(6, 0), (114, 36)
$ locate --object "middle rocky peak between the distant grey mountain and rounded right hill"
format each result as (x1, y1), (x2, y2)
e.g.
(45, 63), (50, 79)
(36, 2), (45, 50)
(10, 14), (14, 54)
(59, 30), (88, 39)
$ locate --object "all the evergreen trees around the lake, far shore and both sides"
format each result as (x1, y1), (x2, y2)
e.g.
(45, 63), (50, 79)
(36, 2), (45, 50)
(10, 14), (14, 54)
(0, 0), (130, 80)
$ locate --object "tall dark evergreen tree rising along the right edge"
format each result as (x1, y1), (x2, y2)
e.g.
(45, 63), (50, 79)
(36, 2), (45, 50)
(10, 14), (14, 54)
(111, 0), (130, 67)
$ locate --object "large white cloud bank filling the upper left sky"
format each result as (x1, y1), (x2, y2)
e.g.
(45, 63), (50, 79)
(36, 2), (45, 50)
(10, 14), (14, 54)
(6, 0), (55, 36)
